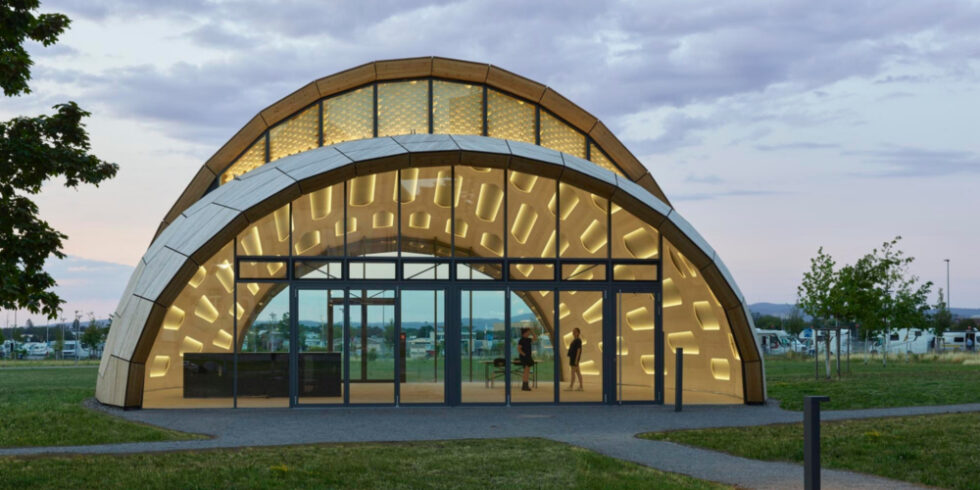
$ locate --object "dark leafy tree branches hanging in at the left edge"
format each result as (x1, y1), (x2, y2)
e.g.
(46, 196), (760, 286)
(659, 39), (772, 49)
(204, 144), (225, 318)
(0, 0), (118, 319)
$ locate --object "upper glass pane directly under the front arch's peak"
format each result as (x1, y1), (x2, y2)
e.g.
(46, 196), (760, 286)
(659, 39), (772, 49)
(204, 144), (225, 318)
(401, 167), (452, 257)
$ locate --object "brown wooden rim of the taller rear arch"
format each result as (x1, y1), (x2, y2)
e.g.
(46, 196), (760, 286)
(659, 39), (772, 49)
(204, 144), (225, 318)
(157, 57), (669, 239)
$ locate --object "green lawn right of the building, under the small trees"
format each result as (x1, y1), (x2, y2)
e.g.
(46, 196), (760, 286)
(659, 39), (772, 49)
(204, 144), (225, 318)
(766, 357), (980, 410)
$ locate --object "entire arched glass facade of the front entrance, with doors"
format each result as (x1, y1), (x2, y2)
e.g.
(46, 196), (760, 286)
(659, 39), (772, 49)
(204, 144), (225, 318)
(143, 165), (742, 408)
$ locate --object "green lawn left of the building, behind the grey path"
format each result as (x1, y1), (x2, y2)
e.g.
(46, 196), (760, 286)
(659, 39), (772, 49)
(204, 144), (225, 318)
(0, 361), (198, 447)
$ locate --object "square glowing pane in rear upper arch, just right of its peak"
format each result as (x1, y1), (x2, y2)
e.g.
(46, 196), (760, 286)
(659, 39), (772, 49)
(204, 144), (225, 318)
(432, 80), (483, 134)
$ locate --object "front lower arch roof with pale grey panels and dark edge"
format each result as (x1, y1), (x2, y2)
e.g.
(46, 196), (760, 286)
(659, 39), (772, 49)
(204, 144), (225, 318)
(99, 134), (765, 404)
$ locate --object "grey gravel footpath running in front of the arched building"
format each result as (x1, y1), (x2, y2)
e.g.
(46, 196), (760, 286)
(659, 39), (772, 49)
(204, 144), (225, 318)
(7, 402), (980, 488)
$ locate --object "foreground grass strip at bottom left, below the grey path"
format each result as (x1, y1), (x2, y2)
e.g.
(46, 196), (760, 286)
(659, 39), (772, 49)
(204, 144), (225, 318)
(0, 439), (728, 489)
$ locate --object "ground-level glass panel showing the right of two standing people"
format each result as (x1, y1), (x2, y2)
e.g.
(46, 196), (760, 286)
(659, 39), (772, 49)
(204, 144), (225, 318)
(558, 291), (603, 402)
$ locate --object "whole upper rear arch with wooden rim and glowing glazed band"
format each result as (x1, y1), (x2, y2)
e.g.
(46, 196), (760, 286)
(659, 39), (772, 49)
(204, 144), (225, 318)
(158, 57), (670, 239)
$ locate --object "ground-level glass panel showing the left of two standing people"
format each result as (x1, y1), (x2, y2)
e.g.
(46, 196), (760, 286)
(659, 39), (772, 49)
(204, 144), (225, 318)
(510, 291), (555, 403)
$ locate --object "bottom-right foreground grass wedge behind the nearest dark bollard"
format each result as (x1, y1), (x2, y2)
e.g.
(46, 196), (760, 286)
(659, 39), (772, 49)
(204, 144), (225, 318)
(640, 413), (980, 488)
